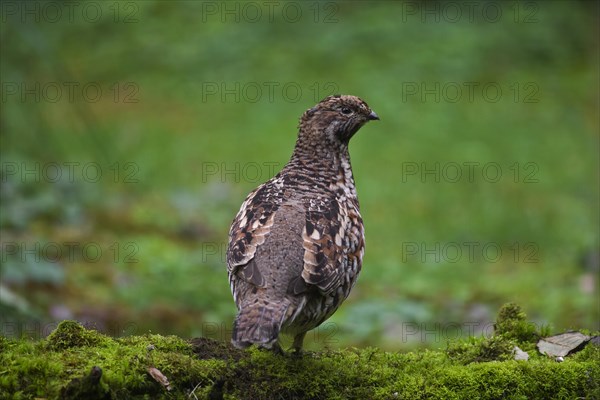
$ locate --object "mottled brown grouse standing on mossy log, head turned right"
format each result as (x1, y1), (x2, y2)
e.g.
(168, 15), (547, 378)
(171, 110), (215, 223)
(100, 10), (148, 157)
(227, 95), (379, 350)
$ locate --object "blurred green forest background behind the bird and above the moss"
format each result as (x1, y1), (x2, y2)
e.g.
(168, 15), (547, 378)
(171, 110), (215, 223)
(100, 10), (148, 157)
(0, 1), (599, 349)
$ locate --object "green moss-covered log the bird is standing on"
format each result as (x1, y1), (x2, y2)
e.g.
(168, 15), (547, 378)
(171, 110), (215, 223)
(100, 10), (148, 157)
(0, 305), (600, 399)
